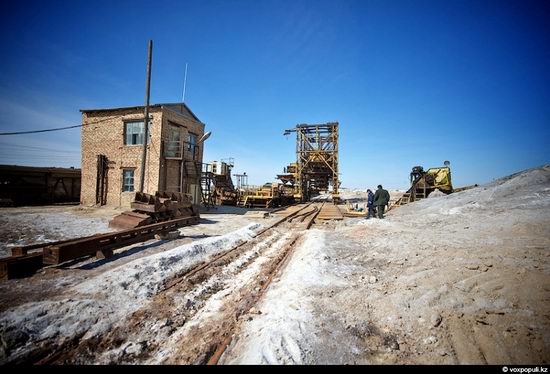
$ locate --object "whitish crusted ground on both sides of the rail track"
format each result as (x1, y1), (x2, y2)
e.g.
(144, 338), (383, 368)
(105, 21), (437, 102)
(0, 165), (550, 364)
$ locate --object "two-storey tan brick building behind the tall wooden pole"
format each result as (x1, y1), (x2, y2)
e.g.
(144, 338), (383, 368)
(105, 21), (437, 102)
(80, 103), (204, 208)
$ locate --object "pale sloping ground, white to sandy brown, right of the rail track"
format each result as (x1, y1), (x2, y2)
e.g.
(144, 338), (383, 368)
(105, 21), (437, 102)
(224, 165), (550, 364)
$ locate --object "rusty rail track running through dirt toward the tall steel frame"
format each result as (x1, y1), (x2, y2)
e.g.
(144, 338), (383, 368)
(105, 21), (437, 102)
(33, 203), (323, 364)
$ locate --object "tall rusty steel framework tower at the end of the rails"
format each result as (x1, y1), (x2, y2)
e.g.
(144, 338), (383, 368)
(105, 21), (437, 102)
(284, 122), (340, 201)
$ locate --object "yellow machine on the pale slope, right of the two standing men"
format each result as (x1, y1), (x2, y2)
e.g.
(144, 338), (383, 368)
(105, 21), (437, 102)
(392, 161), (453, 207)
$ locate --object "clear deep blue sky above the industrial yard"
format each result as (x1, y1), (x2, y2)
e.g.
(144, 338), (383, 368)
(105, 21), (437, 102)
(0, 0), (550, 188)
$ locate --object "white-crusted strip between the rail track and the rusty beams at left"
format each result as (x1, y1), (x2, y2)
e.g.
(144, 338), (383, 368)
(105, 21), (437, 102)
(0, 224), (260, 361)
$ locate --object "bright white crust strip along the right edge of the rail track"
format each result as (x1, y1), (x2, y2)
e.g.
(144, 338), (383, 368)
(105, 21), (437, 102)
(222, 230), (338, 364)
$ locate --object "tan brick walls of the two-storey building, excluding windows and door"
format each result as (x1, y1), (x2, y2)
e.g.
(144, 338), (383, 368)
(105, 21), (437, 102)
(80, 106), (208, 208)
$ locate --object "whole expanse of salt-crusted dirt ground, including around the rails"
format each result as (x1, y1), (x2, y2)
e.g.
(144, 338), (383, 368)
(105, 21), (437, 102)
(0, 165), (550, 364)
